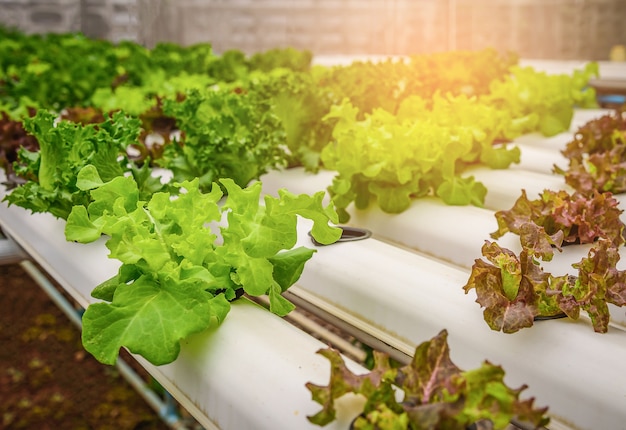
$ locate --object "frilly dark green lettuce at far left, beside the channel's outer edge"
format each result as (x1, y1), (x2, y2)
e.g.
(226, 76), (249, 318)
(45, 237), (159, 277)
(5, 110), (145, 219)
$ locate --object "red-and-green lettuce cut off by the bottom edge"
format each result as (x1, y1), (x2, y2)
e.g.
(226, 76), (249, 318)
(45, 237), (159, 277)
(307, 330), (549, 429)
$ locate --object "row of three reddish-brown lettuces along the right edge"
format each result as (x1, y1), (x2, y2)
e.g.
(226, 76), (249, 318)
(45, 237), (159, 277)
(464, 107), (626, 333)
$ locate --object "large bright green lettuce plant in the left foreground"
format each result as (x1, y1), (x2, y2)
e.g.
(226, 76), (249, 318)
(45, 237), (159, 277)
(65, 174), (341, 364)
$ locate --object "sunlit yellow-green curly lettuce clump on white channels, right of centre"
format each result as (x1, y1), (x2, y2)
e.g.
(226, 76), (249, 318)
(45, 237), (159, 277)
(321, 96), (519, 221)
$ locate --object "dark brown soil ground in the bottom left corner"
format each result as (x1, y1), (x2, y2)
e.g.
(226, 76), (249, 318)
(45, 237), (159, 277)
(0, 264), (184, 430)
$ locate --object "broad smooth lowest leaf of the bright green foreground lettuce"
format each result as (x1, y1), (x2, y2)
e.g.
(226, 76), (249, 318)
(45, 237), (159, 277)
(82, 276), (227, 365)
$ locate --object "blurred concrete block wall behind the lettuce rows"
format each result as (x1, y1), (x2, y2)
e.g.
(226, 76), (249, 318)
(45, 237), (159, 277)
(0, 0), (626, 60)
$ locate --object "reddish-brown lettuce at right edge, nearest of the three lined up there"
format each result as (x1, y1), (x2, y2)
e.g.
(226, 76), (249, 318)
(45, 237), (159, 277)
(464, 235), (626, 333)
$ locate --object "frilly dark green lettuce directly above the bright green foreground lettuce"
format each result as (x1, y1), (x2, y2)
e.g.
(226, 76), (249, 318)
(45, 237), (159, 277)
(160, 89), (287, 189)
